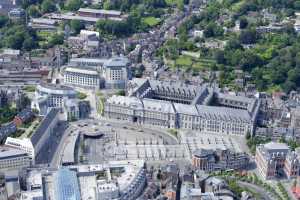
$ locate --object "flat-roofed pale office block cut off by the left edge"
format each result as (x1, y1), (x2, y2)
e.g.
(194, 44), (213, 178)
(0, 146), (32, 172)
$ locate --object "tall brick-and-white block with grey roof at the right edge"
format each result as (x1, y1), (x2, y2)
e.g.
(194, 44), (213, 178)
(255, 142), (300, 179)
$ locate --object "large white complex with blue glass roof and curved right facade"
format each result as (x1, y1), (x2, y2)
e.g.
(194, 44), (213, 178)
(39, 160), (146, 200)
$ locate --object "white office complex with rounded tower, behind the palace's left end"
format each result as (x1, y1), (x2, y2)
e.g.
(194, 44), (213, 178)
(64, 57), (131, 89)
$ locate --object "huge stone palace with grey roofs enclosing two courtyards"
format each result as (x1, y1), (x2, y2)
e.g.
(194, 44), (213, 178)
(104, 79), (260, 135)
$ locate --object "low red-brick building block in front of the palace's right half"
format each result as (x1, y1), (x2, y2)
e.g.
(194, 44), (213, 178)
(192, 148), (249, 172)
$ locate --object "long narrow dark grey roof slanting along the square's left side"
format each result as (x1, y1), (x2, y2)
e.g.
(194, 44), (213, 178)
(30, 108), (59, 146)
